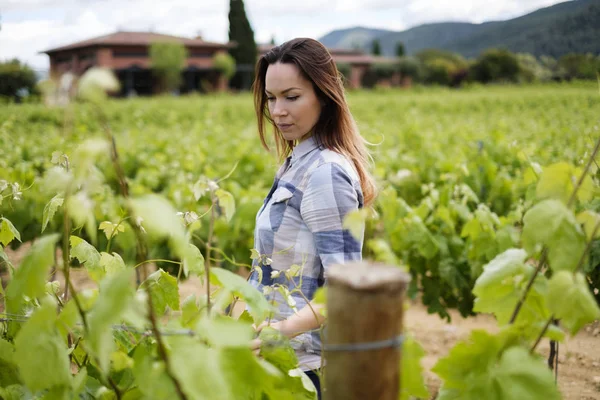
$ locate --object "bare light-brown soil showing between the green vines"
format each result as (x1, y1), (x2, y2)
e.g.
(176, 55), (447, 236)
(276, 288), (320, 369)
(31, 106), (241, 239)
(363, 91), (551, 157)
(0, 243), (600, 400)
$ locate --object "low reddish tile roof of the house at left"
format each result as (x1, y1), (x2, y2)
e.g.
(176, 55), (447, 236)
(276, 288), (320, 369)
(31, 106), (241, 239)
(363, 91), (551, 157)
(40, 31), (234, 54)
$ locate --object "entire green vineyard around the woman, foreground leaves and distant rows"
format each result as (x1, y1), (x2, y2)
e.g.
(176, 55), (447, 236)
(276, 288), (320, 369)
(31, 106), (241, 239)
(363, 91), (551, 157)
(0, 83), (600, 400)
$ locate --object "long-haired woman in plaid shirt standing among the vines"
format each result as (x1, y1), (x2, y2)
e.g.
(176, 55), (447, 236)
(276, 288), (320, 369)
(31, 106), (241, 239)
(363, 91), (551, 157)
(250, 38), (376, 397)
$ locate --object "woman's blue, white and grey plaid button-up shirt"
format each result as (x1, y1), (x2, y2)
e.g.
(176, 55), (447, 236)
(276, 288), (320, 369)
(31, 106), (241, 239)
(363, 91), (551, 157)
(250, 137), (363, 370)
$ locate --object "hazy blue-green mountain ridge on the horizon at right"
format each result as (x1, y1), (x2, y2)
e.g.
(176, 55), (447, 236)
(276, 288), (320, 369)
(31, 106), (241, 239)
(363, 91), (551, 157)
(319, 0), (600, 58)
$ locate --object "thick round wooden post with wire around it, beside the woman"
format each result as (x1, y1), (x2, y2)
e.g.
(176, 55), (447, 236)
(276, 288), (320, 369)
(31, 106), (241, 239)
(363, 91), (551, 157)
(323, 262), (410, 400)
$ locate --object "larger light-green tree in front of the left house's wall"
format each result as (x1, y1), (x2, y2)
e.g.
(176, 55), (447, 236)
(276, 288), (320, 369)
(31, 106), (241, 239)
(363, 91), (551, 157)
(150, 41), (187, 91)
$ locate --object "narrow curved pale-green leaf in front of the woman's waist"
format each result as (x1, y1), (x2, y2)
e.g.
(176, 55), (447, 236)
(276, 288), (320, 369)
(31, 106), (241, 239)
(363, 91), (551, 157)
(210, 268), (270, 323)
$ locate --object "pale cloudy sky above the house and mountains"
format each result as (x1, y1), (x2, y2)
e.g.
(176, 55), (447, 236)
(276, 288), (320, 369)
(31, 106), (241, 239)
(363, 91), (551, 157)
(0, 0), (561, 69)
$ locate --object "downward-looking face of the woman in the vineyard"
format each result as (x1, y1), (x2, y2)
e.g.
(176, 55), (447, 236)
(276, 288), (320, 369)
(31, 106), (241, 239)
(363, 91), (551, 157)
(265, 62), (321, 141)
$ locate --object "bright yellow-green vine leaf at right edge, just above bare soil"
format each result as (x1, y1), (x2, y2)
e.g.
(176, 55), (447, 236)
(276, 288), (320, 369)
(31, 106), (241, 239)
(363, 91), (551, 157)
(548, 271), (600, 335)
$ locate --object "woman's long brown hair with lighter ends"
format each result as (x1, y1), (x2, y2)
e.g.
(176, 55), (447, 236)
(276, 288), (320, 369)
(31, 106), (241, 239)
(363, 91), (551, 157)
(253, 38), (377, 206)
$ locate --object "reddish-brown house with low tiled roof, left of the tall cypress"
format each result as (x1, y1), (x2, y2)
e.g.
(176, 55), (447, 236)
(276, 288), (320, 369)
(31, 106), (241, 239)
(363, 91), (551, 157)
(41, 31), (233, 96)
